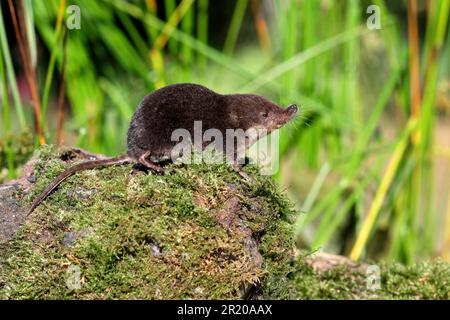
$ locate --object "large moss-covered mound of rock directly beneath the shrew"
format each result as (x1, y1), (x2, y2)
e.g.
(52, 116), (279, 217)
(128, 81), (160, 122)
(0, 147), (293, 299)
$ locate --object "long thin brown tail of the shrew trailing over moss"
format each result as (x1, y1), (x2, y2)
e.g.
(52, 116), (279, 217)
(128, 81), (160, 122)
(27, 154), (132, 216)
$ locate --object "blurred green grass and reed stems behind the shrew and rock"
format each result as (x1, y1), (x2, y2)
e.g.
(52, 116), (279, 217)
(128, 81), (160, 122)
(0, 0), (450, 263)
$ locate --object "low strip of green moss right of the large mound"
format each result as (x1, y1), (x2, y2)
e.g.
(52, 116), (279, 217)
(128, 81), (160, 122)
(266, 256), (450, 299)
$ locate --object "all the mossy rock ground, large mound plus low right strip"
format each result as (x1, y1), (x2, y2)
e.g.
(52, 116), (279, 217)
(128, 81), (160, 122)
(0, 147), (450, 299)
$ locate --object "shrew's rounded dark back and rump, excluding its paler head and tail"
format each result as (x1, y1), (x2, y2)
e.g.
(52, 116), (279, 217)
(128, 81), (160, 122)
(127, 84), (226, 159)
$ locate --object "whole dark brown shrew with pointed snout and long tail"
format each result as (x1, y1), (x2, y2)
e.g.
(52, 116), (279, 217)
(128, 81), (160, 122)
(28, 84), (297, 214)
